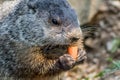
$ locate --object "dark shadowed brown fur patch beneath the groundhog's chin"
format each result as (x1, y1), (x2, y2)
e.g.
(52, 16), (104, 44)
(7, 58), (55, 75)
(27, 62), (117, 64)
(41, 45), (68, 59)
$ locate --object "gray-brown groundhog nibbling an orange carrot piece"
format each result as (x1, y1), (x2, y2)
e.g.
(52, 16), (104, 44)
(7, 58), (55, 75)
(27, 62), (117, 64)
(0, 0), (86, 80)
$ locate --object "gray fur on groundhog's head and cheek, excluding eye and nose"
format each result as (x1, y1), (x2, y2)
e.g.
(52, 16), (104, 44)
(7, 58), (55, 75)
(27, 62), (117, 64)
(0, 0), (80, 46)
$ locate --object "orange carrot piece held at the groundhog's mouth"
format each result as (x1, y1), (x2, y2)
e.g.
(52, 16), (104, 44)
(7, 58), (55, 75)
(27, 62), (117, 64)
(68, 46), (78, 60)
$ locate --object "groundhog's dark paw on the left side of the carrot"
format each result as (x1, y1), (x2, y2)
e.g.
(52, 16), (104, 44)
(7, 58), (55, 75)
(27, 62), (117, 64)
(59, 54), (75, 70)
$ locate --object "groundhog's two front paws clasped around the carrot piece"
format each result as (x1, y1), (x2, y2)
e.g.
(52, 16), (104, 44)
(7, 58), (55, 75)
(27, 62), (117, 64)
(57, 50), (86, 71)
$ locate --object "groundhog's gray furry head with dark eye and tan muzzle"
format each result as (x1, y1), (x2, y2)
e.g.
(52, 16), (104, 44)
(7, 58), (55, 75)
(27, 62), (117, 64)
(5, 0), (82, 58)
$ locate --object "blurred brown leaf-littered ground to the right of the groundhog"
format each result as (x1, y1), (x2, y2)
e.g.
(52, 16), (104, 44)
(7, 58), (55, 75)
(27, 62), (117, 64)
(61, 0), (120, 80)
